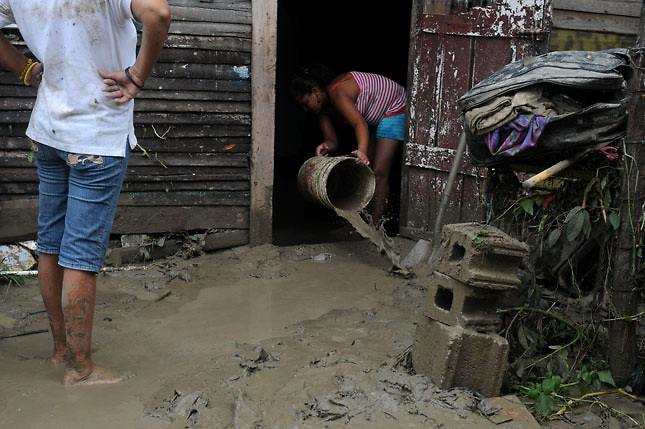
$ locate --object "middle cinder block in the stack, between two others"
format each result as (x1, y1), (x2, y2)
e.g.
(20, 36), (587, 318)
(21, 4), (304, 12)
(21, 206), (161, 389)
(423, 271), (501, 333)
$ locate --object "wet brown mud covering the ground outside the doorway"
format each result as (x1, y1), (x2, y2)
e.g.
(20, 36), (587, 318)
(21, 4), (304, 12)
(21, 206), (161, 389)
(0, 239), (638, 428)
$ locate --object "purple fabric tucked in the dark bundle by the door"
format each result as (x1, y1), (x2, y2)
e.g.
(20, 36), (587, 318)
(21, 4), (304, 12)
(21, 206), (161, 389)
(486, 114), (551, 156)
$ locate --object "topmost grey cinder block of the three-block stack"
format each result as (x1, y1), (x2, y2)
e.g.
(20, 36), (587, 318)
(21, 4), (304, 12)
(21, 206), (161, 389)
(433, 223), (529, 290)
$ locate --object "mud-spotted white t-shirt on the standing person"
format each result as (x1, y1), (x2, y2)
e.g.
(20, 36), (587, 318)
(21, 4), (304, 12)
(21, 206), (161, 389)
(0, 0), (137, 156)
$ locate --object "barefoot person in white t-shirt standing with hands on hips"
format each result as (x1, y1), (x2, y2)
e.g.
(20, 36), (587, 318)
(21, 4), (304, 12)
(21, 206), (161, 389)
(0, 0), (170, 385)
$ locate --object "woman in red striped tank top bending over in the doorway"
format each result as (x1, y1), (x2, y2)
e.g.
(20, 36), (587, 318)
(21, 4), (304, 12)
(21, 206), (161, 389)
(291, 65), (406, 225)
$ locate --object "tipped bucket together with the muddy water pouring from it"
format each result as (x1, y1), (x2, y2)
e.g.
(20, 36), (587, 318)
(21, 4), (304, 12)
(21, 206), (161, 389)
(298, 156), (409, 275)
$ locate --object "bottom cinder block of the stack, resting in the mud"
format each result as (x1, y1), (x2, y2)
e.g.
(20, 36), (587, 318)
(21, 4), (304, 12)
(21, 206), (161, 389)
(412, 316), (509, 397)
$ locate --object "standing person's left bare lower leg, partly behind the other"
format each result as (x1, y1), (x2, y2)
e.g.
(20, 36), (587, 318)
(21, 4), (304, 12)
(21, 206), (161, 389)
(38, 253), (67, 363)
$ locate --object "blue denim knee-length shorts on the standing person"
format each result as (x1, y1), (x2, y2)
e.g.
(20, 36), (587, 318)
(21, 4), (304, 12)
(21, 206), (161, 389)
(32, 142), (130, 272)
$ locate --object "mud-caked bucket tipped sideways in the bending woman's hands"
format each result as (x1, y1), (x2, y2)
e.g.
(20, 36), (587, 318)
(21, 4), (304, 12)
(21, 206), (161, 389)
(298, 156), (376, 210)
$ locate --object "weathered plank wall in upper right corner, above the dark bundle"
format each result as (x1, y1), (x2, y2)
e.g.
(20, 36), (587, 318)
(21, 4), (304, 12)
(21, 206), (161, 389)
(549, 0), (642, 51)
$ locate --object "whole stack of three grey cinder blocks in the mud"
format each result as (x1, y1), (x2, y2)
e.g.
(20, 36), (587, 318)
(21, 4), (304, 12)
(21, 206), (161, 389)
(412, 223), (529, 397)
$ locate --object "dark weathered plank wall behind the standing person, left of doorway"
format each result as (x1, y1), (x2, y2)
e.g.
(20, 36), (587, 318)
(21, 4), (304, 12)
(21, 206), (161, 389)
(0, 0), (252, 242)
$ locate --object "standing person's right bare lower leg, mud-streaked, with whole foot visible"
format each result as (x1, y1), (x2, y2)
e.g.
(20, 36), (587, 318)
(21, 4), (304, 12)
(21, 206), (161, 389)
(62, 268), (125, 386)
